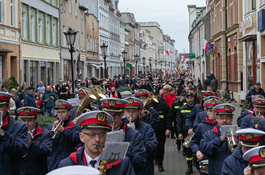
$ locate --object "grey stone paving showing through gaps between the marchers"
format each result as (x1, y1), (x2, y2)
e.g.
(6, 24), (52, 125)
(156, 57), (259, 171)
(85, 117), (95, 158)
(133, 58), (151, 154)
(155, 103), (241, 175)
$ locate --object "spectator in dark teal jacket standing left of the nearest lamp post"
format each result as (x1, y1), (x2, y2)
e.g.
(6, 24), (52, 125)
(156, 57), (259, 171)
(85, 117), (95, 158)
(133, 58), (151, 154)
(41, 86), (57, 117)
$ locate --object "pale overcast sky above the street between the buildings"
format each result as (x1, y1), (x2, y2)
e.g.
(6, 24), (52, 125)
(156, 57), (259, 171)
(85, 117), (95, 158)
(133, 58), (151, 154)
(119, 0), (206, 53)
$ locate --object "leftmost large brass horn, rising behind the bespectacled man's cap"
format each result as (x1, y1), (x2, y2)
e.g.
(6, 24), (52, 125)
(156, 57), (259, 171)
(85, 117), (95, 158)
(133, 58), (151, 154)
(75, 89), (97, 119)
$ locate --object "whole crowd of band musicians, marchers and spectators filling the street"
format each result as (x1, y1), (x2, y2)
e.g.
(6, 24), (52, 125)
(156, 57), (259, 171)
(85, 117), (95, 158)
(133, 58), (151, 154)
(0, 72), (265, 175)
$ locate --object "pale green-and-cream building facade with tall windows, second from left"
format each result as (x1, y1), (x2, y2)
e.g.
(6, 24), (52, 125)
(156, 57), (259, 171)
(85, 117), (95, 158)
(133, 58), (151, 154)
(21, 0), (60, 87)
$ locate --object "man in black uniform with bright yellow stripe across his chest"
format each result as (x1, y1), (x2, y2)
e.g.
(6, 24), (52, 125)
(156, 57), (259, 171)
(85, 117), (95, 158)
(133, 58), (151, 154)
(177, 93), (195, 174)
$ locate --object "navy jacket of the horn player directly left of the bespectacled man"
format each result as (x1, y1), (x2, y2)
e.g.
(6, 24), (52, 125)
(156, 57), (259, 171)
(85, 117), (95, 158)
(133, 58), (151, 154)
(47, 119), (81, 171)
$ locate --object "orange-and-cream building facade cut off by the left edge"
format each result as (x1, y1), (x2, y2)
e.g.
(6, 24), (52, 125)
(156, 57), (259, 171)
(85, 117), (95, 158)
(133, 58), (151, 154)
(0, 0), (20, 85)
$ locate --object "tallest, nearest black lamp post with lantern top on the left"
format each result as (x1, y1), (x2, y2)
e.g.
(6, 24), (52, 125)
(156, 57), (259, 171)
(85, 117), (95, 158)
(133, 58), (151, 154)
(64, 27), (76, 95)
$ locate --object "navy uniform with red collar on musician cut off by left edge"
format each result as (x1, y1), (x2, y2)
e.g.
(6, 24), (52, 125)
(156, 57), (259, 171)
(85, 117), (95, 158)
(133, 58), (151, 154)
(0, 114), (28, 175)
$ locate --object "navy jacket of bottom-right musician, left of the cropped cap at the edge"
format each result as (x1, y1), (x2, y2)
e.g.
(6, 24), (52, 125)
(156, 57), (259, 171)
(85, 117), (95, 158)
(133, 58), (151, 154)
(222, 146), (248, 175)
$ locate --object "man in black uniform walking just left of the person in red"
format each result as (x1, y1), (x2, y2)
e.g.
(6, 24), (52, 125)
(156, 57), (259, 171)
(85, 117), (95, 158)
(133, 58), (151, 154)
(149, 89), (172, 172)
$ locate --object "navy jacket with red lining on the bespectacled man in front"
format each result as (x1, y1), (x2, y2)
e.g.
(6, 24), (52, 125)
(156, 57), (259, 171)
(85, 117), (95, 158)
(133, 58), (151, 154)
(58, 147), (135, 175)
